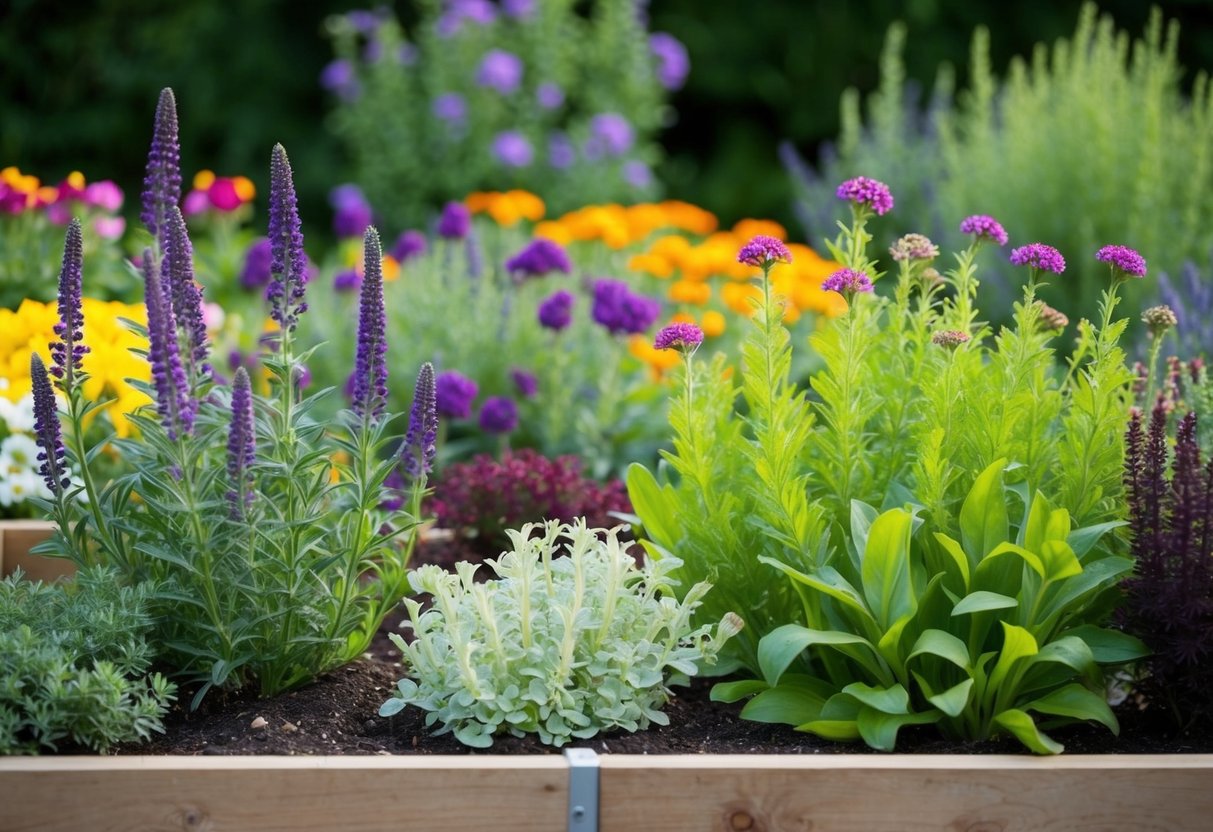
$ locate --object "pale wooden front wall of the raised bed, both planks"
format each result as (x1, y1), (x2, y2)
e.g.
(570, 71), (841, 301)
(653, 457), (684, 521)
(0, 754), (1213, 832)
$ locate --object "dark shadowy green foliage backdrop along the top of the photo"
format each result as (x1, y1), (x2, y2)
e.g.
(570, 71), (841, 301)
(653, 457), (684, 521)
(7, 0), (1213, 235)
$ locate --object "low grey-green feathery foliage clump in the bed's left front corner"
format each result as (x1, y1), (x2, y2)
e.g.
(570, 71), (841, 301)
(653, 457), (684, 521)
(0, 568), (176, 754)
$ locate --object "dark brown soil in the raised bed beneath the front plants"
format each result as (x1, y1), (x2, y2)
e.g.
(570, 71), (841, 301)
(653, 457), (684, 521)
(119, 541), (1213, 754)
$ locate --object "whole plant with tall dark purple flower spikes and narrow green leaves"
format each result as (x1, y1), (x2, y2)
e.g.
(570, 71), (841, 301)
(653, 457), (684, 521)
(32, 89), (437, 705)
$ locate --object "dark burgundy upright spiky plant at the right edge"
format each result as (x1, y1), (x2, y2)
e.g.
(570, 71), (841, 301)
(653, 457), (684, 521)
(1123, 407), (1213, 729)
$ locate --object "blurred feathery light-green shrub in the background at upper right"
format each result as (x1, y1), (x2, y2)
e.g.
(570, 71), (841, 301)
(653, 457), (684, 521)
(786, 4), (1213, 329)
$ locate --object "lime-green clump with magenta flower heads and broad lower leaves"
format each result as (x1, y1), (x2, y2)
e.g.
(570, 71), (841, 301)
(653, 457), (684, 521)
(628, 177), (1145, 753)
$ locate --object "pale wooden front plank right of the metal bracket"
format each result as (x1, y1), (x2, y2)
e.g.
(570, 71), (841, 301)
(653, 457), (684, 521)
(599, 754), (1213, 832)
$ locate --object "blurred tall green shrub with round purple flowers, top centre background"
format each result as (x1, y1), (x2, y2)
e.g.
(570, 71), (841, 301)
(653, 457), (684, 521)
(321, 0), (685, 227)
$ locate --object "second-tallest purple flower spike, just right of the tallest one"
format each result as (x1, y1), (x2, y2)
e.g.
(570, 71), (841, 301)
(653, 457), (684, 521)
(266, 144), (307, 332)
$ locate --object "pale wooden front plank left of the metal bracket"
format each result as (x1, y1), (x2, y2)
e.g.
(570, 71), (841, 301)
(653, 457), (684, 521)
(0, 756), (569, 832)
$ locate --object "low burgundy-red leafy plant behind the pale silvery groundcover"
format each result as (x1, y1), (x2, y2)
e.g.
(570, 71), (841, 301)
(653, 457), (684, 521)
(429, 449), (632, 554)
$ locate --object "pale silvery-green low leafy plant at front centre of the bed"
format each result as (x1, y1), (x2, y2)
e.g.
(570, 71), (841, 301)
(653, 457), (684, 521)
(380, 520), (742, 748)
